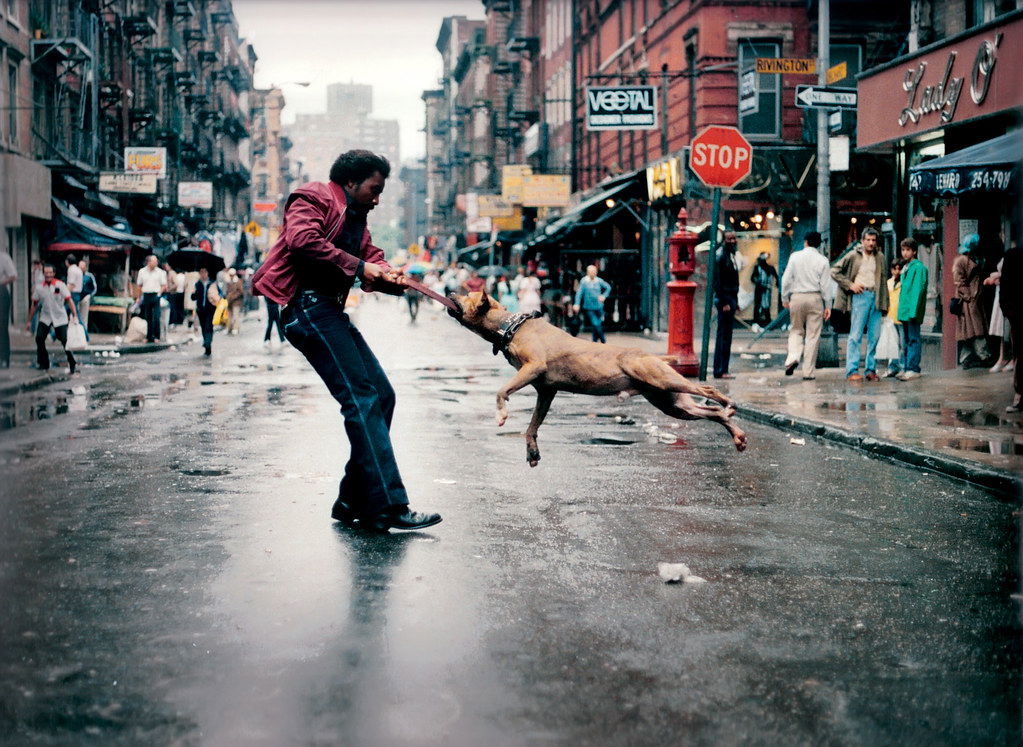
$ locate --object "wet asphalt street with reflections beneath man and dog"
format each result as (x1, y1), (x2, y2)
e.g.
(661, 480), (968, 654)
(0, 299), (1021, 745)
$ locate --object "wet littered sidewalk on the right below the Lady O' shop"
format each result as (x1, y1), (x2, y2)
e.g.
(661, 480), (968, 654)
(608, 329), (1023, 497)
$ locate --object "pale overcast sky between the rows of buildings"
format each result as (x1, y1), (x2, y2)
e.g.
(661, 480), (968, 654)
(233, 0), (483, 160)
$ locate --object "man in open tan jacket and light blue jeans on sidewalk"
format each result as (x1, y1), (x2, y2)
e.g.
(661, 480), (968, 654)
(832, 227), (888, 382)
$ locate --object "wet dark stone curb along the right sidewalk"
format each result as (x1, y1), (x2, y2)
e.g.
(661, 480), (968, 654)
(737, 405), (1023, 500)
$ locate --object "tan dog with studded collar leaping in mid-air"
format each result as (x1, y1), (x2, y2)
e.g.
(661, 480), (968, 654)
(449, 292), (746, 467)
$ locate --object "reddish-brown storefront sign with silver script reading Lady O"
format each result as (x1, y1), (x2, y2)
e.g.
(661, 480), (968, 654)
(856, 14), (1023, 147)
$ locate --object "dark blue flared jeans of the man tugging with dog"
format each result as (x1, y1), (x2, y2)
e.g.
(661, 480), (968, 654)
(283, 296), (408, 515)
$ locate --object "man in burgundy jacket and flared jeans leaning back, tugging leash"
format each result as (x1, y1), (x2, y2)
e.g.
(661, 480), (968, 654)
(254, 150), (441, 531)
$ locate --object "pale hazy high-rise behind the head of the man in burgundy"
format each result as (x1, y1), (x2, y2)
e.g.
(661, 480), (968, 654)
(287, 78), (403, 228)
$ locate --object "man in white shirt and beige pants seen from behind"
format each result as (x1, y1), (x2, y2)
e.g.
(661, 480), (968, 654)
(782, 231), (834, 380)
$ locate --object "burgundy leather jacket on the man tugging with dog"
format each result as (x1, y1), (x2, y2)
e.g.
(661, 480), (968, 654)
(253, 182), (390, 305)
